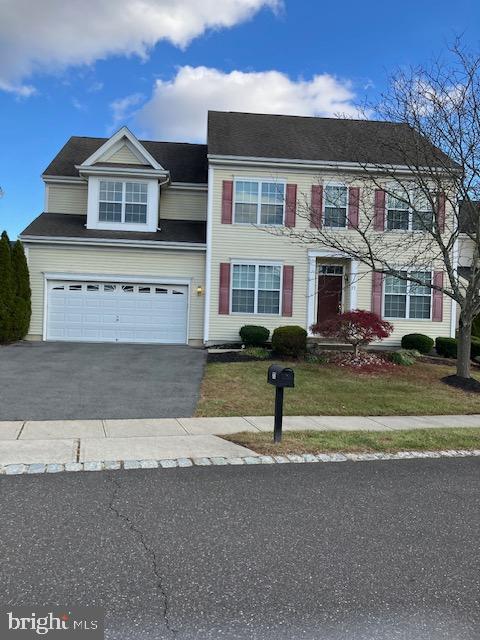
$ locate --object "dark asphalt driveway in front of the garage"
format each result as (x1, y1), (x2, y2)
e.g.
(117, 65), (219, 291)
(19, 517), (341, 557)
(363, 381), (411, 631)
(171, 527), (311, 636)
(0, 342), (206, 420)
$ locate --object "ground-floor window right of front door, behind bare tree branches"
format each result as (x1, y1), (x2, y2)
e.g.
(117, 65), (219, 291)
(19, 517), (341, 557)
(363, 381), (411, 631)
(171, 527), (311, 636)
(383, 271), (432, 320)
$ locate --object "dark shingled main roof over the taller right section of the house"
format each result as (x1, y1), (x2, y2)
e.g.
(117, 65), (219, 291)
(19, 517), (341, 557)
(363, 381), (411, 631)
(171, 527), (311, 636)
(208, 111), (456, 167)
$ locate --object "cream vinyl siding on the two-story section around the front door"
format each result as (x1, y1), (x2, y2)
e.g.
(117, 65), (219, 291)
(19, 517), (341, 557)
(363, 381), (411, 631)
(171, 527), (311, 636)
(208, 166), (451, 345)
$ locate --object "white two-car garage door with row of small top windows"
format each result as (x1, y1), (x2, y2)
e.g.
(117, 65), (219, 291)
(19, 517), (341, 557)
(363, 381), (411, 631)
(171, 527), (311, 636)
(47, 281), (188, 344)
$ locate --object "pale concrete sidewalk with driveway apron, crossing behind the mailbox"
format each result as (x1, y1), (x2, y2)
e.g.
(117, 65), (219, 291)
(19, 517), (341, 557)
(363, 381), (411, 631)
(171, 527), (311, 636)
(0, 414), (480, 465)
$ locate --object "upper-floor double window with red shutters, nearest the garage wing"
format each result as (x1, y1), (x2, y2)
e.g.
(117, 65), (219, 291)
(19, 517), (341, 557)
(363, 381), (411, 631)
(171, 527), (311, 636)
(235, 180), (285, 225)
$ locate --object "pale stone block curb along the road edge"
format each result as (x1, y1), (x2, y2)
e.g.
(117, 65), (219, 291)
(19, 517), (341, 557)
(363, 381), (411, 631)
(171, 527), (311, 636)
(0, 449), (480, 476)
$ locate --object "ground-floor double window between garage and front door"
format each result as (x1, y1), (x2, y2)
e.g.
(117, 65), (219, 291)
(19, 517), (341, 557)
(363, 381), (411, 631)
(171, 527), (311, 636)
(232, 264), (282, 314)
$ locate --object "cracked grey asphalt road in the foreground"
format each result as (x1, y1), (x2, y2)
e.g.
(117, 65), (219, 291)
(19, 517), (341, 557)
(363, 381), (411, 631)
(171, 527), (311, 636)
(0, 458), (480, 640)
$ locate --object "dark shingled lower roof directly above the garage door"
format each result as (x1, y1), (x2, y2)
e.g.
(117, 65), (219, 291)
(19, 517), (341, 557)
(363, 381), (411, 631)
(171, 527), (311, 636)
(20, 213), (206, 244)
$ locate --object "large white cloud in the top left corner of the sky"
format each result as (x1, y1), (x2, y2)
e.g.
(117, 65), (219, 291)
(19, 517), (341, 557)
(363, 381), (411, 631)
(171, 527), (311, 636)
(0, 0), (282, 95)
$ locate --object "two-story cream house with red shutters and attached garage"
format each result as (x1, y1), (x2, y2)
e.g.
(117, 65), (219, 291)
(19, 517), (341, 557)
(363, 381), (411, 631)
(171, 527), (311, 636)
(20, 112), (456, 345)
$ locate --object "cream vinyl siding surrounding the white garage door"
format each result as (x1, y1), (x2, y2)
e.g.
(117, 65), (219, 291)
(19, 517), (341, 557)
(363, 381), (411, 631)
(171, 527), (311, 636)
(25, 243), (205, 341)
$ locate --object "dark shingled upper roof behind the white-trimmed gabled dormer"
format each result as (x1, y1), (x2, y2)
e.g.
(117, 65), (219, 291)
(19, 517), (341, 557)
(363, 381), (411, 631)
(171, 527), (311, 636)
(43, 136), (208, 184)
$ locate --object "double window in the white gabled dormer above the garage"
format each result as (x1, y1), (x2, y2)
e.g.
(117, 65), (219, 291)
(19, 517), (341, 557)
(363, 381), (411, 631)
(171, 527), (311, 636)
(98, 180), (148, 224)
